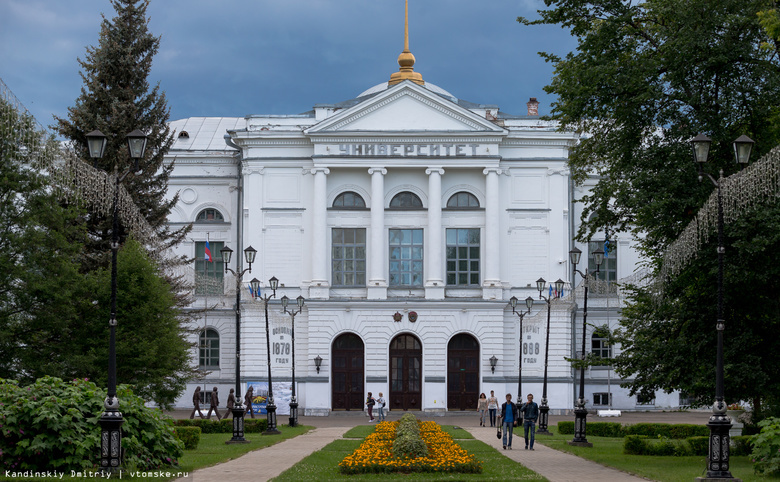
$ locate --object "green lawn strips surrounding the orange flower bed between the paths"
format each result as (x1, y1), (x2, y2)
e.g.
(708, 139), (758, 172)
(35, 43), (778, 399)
(272, 425), (547, 482)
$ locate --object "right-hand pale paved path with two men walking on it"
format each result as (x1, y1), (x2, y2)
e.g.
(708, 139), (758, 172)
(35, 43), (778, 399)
(466, 427), (647, 482)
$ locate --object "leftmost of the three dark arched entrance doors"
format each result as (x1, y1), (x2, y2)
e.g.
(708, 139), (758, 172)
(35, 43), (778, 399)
(331, 333), (366, 410)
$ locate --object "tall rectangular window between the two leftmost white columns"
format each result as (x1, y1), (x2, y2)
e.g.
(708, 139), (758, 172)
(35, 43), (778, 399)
(330, 228), (366, 287)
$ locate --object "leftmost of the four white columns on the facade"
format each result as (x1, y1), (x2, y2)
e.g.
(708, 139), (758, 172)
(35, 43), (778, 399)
(309, 167), (330, 299)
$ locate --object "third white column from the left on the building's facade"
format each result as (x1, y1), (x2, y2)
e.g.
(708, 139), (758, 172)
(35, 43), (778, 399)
(425, 167), (444, 299)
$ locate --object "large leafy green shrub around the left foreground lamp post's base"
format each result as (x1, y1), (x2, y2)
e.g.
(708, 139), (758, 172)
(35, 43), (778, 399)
(0, 377), (184, 471)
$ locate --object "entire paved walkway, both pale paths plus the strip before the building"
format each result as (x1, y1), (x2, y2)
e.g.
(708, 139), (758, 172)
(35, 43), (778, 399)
(171, 412), (707, 482)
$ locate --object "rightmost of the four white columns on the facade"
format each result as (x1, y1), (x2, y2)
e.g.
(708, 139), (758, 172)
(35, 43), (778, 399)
(482, 167), (503, 299)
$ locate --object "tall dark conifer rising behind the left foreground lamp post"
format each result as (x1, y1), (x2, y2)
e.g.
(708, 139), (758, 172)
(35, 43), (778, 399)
(55, 0), (190, 270)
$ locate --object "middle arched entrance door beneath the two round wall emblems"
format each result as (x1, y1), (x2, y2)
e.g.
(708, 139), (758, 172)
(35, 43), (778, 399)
(390, 335), (422, 410)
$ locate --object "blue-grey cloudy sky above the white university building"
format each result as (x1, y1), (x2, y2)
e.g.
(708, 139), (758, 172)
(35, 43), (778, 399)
(0, 0), (576, 134)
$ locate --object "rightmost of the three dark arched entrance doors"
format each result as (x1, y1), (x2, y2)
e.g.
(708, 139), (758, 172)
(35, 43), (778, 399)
(447, 333), (479, 410)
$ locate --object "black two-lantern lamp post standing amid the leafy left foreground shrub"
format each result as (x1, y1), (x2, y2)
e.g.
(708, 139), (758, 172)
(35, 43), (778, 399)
(86, 129), (146, 473)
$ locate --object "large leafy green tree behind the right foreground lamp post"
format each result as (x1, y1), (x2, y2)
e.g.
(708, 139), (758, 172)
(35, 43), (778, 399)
(518, 0), (780, 410)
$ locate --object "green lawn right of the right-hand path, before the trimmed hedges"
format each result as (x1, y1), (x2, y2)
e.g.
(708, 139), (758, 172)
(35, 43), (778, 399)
(536, 426), (780, 482)
